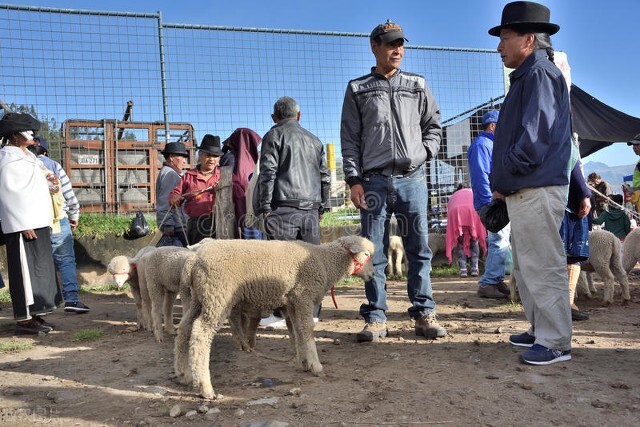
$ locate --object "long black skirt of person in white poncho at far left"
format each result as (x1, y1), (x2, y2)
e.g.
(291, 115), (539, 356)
(4, 227), (62, 320)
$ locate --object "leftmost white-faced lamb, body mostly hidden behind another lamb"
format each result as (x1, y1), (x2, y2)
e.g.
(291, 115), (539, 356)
(107, 246), (156, 330)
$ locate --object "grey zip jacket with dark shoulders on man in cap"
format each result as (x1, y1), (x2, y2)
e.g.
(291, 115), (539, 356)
(340, 68), (442, 186)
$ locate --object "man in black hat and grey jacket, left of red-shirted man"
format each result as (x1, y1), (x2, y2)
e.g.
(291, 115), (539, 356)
(156, 142), (189, 247)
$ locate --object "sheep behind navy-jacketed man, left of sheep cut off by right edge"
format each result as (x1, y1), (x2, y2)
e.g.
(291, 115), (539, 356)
(581, 230), (631, 304)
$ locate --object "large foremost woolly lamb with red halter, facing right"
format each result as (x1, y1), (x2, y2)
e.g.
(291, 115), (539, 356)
(174, 236), (374, 399)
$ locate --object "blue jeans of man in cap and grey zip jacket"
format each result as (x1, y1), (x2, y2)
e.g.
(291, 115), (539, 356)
(360, 166), (436, 322)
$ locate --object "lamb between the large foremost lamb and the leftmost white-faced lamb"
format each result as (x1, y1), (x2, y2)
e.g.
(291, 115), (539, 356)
(137, 246), (196, 342)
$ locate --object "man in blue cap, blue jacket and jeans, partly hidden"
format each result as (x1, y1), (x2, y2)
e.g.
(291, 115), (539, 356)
(467, 110), (511, 299)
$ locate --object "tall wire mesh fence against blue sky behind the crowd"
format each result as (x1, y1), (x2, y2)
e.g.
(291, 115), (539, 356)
(0, 5), (505, 226)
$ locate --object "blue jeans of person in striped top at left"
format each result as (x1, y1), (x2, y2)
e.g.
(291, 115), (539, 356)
(51, 218), (80, 302)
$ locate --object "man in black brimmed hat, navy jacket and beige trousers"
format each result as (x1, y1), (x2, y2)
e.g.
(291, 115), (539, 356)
(489, 1), (573, 365)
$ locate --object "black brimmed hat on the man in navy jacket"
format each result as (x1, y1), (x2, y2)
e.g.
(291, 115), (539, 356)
(489, 1), (560, 37)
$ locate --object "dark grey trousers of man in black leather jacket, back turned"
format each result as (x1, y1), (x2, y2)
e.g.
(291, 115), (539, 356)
(264, 206), (322, 317)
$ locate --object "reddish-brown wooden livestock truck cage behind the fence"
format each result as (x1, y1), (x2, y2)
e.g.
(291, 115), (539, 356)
(62, 119), (196, 214)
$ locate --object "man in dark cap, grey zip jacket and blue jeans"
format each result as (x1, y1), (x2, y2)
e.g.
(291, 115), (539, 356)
(340, 21), (446, 342)
